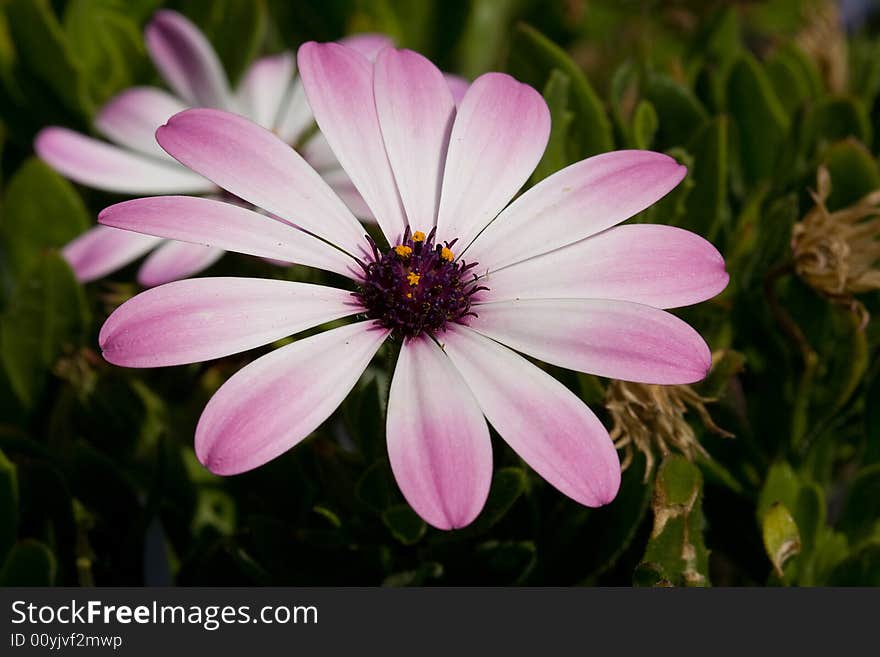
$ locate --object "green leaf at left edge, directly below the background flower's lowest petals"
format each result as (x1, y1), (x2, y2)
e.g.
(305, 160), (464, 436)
(0, 254), (89, 406)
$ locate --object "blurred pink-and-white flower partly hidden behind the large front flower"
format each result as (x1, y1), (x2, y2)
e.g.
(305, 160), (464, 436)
(34, 10), (392, 286)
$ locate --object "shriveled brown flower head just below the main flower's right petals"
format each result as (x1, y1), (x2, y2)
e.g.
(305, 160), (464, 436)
(605, 381), (733, 481)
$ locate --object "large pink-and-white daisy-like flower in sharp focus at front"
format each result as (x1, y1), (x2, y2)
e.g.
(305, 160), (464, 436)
(100, 43), (728, 529)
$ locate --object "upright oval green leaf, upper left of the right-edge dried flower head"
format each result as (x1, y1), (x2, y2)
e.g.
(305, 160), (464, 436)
(727, 55), (789, 185)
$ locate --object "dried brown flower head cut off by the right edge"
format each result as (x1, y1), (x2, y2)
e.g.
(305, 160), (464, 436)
(791, 167), (880, 326)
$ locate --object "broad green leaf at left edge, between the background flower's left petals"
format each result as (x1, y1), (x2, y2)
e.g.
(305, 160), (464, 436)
(0, 158), (91, 280)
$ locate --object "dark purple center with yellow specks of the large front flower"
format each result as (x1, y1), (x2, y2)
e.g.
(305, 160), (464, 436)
(354, 228), (488, 338)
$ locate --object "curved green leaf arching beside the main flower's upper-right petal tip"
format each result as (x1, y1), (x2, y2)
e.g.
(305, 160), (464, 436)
(510, 23), (614, 161)
